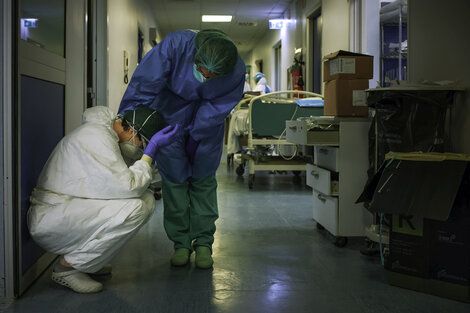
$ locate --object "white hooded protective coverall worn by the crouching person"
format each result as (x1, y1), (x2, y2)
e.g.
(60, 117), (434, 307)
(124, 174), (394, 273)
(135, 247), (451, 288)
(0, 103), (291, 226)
(28, 106), (155, 273)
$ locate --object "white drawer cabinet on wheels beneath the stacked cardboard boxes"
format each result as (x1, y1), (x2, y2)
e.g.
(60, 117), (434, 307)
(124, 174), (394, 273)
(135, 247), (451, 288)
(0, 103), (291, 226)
(286, 117), (372, 246)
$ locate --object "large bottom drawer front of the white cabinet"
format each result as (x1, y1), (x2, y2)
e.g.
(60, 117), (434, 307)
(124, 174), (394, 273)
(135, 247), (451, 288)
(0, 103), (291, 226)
(313, 190), (338, 236)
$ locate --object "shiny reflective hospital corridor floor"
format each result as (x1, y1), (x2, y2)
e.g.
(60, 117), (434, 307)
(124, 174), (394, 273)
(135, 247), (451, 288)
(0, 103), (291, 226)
(5, 157), (470, 313)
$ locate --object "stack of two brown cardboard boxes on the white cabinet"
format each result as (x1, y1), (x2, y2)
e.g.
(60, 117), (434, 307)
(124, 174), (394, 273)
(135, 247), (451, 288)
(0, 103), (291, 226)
(323, 50), (373, 116)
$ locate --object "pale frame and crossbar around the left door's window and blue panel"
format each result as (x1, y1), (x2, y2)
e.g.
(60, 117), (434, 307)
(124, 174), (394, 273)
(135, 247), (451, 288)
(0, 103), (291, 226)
(5, 0), (87, 298)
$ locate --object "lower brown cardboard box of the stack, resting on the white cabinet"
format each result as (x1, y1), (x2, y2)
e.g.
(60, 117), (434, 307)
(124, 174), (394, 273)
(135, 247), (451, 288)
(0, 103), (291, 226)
(324, 79), (369, 116)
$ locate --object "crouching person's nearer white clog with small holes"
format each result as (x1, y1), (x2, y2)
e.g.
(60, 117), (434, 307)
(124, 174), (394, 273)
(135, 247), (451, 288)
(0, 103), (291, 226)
(52, 270), (103, 293)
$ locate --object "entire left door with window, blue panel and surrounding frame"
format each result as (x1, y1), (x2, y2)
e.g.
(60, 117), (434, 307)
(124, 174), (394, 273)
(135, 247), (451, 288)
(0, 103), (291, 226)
(5, 0), (87, 297)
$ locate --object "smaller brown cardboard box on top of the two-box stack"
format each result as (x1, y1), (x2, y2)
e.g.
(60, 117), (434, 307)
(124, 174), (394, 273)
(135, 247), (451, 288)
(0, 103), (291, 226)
(323, 50), (374, 82)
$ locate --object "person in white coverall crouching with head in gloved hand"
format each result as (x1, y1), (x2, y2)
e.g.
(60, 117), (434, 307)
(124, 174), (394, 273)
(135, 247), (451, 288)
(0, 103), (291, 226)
(28, 106), (179, 293)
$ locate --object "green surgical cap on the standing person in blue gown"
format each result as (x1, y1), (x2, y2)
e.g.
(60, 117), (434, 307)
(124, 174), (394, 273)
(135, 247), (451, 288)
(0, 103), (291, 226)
(194, 29), (238, 76)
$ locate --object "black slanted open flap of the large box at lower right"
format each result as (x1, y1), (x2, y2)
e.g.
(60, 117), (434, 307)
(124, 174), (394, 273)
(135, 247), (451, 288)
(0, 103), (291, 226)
(358, 156), (468, 221)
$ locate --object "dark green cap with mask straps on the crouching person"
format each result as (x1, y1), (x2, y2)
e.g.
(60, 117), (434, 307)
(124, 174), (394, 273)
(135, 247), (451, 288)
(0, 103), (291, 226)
(124, 108), (166, 142)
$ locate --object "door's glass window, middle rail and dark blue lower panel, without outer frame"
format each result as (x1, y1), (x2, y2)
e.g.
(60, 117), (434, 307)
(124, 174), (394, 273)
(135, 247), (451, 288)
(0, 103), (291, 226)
(14, 0), (66, 294)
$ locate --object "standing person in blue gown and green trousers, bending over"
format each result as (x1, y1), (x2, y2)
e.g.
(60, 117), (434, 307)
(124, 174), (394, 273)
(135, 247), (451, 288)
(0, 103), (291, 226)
(119, 30), (245, 268)
